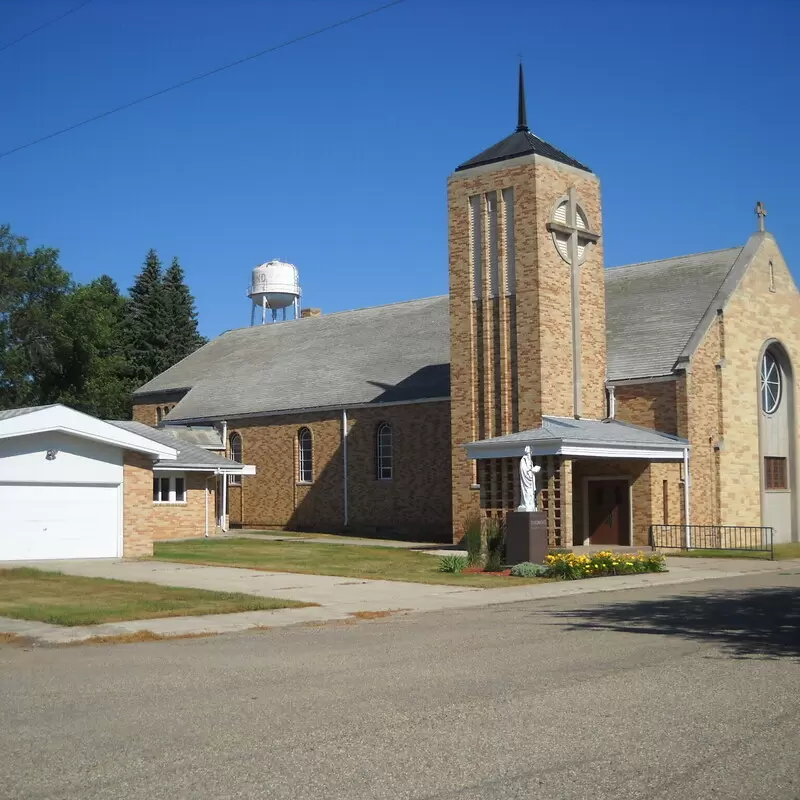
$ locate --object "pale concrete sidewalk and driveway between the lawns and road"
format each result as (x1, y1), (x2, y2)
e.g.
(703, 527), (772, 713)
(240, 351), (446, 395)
(0, 558), (800, 644)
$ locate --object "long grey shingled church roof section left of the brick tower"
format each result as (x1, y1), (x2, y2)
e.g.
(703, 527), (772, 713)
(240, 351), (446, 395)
(134, 295), (450, 422)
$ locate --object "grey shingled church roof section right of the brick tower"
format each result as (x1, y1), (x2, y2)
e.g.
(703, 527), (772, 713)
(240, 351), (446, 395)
(606, 247), (744, 381)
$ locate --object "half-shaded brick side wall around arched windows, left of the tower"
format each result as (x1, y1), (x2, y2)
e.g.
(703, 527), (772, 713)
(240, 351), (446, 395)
(222, 401), (451, 539)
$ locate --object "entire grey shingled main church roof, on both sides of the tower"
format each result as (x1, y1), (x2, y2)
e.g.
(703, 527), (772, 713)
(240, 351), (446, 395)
(135, 234), (769, 422)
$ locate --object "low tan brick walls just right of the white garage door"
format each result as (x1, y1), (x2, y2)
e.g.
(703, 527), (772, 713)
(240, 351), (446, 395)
(122, 452), (215, 558)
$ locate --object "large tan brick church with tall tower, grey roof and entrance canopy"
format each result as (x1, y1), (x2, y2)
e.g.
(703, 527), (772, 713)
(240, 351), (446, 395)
(134, 69), (800, 547)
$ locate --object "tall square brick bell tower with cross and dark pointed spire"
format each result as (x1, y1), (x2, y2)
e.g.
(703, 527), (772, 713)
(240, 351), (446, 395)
(448, 65), (606, 527)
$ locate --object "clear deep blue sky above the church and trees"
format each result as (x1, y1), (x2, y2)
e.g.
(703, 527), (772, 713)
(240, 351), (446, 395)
(0, 0), (800, 336)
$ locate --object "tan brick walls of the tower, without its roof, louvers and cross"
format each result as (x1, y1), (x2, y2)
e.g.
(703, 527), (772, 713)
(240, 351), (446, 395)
(448, 155), (606, 541)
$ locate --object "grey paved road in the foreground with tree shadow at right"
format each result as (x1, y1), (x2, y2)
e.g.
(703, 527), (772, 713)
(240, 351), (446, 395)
(0, 566), (800, 800)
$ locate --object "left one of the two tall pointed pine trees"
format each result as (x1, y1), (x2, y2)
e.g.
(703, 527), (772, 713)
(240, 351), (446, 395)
(125, 249), (170, 386)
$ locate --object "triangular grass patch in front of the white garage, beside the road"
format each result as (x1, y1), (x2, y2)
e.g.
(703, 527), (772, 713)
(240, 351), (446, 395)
(0, 567), (308, 625)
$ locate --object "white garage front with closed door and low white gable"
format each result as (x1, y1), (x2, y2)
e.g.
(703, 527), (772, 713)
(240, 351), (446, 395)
(0, 405), (177, 561)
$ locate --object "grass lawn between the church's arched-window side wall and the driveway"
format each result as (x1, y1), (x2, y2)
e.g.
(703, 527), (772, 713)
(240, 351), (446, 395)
(155, 539), (548, 588)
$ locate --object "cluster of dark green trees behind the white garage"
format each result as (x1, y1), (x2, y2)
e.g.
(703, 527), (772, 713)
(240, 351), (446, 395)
(0, 225), (205, 418)
